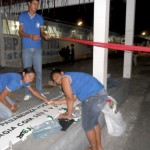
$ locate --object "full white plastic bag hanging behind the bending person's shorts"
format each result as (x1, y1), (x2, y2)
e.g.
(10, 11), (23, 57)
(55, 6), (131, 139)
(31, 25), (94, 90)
(102, 96), (126, 136)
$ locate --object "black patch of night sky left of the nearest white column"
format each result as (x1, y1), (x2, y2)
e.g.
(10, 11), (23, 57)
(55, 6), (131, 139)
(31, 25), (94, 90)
(38, 3), (94, 27)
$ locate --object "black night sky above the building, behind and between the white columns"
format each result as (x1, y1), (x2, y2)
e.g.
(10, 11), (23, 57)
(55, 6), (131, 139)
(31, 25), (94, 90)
(39, 0), (150, 35)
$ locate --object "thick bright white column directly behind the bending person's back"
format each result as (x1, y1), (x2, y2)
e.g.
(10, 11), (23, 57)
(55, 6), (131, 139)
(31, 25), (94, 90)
(93, 0), (110, 88)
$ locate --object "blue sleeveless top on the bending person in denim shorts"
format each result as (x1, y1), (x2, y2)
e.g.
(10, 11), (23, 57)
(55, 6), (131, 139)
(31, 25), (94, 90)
(64, 72), (104, 101)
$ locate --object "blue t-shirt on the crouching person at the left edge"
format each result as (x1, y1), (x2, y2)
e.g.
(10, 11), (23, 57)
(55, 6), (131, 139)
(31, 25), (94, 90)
(0, 73), (30, 93)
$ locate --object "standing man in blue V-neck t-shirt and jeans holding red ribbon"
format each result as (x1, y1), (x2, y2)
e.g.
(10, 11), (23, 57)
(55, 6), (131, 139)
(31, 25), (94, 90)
(19, 0), (50, 100)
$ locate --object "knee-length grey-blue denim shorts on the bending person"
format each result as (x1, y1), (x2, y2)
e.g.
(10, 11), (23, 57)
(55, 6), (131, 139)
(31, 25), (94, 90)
(82, 89), (108, 132)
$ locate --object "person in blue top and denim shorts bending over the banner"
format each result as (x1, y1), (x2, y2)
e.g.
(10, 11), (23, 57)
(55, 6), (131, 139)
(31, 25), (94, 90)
(48, 69), (108, 150)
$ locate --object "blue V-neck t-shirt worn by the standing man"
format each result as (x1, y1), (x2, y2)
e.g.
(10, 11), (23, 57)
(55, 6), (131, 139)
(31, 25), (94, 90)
(19, 12), (44, 49)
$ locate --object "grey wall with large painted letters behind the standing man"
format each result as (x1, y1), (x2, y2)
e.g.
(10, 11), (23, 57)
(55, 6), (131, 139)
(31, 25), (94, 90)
(4, 35), (92, 67)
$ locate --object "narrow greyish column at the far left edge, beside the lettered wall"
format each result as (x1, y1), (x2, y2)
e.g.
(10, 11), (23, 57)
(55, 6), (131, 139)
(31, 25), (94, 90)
(0, 12), (6, 67)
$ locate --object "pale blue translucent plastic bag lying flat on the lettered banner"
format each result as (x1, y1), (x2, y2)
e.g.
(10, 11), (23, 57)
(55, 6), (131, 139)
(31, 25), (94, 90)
(32, 119), (62, 139)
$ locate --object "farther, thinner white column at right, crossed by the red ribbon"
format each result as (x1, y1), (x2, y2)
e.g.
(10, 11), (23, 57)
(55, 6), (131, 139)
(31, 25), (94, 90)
(123, 0), (136, 78)
